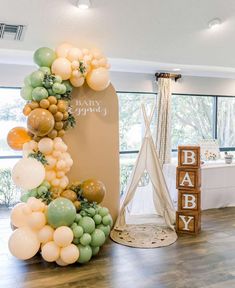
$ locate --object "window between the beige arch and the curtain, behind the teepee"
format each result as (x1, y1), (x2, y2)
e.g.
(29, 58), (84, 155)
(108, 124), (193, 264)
(118, 92), (156, 193)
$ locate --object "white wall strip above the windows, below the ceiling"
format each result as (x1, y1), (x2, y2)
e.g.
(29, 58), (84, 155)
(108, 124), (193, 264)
(0, 64), (235, 96)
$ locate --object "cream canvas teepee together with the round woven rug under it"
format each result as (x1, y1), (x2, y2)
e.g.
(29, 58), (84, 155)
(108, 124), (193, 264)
(111, 105), (177, 248)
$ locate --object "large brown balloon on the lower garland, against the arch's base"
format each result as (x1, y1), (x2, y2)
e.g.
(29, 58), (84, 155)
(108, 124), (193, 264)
(82, 179), (106, 203)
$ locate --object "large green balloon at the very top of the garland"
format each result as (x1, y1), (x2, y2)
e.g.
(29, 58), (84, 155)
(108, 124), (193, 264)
(33, 47), (56, 67)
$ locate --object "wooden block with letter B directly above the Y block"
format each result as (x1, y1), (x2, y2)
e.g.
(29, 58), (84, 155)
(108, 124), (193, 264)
(178, 190), (201, 212)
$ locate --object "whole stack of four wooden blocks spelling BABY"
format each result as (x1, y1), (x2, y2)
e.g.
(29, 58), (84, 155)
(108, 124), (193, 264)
(176, 146), (201, 235)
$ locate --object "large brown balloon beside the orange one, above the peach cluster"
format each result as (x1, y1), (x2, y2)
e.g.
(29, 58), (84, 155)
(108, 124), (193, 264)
(27, 108), (55, 136)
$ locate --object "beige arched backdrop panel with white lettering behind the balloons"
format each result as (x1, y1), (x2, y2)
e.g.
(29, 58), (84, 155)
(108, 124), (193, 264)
(64, 84), (119, 221)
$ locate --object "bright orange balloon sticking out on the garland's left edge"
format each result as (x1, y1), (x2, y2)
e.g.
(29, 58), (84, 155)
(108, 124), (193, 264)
(7, 127), (32, 150)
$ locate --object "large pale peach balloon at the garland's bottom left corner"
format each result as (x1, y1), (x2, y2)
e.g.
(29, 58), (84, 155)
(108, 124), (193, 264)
(8, 226), (40, 260)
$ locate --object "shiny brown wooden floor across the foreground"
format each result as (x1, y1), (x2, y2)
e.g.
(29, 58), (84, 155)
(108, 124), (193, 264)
(0, 208), (235, 288)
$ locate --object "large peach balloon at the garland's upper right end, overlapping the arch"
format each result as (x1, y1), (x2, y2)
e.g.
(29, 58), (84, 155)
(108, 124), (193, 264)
(86, 67), (110, 91)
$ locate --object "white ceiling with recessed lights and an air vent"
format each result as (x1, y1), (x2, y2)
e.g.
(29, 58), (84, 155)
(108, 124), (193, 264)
(0, 0), (235, 75)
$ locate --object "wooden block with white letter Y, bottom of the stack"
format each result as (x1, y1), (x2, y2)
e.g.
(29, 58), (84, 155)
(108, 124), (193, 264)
(176, 212), (201, 235)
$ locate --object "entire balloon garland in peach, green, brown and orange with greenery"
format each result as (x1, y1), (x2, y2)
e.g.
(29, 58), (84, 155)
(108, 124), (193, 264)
(7, 43), (113, 266)
